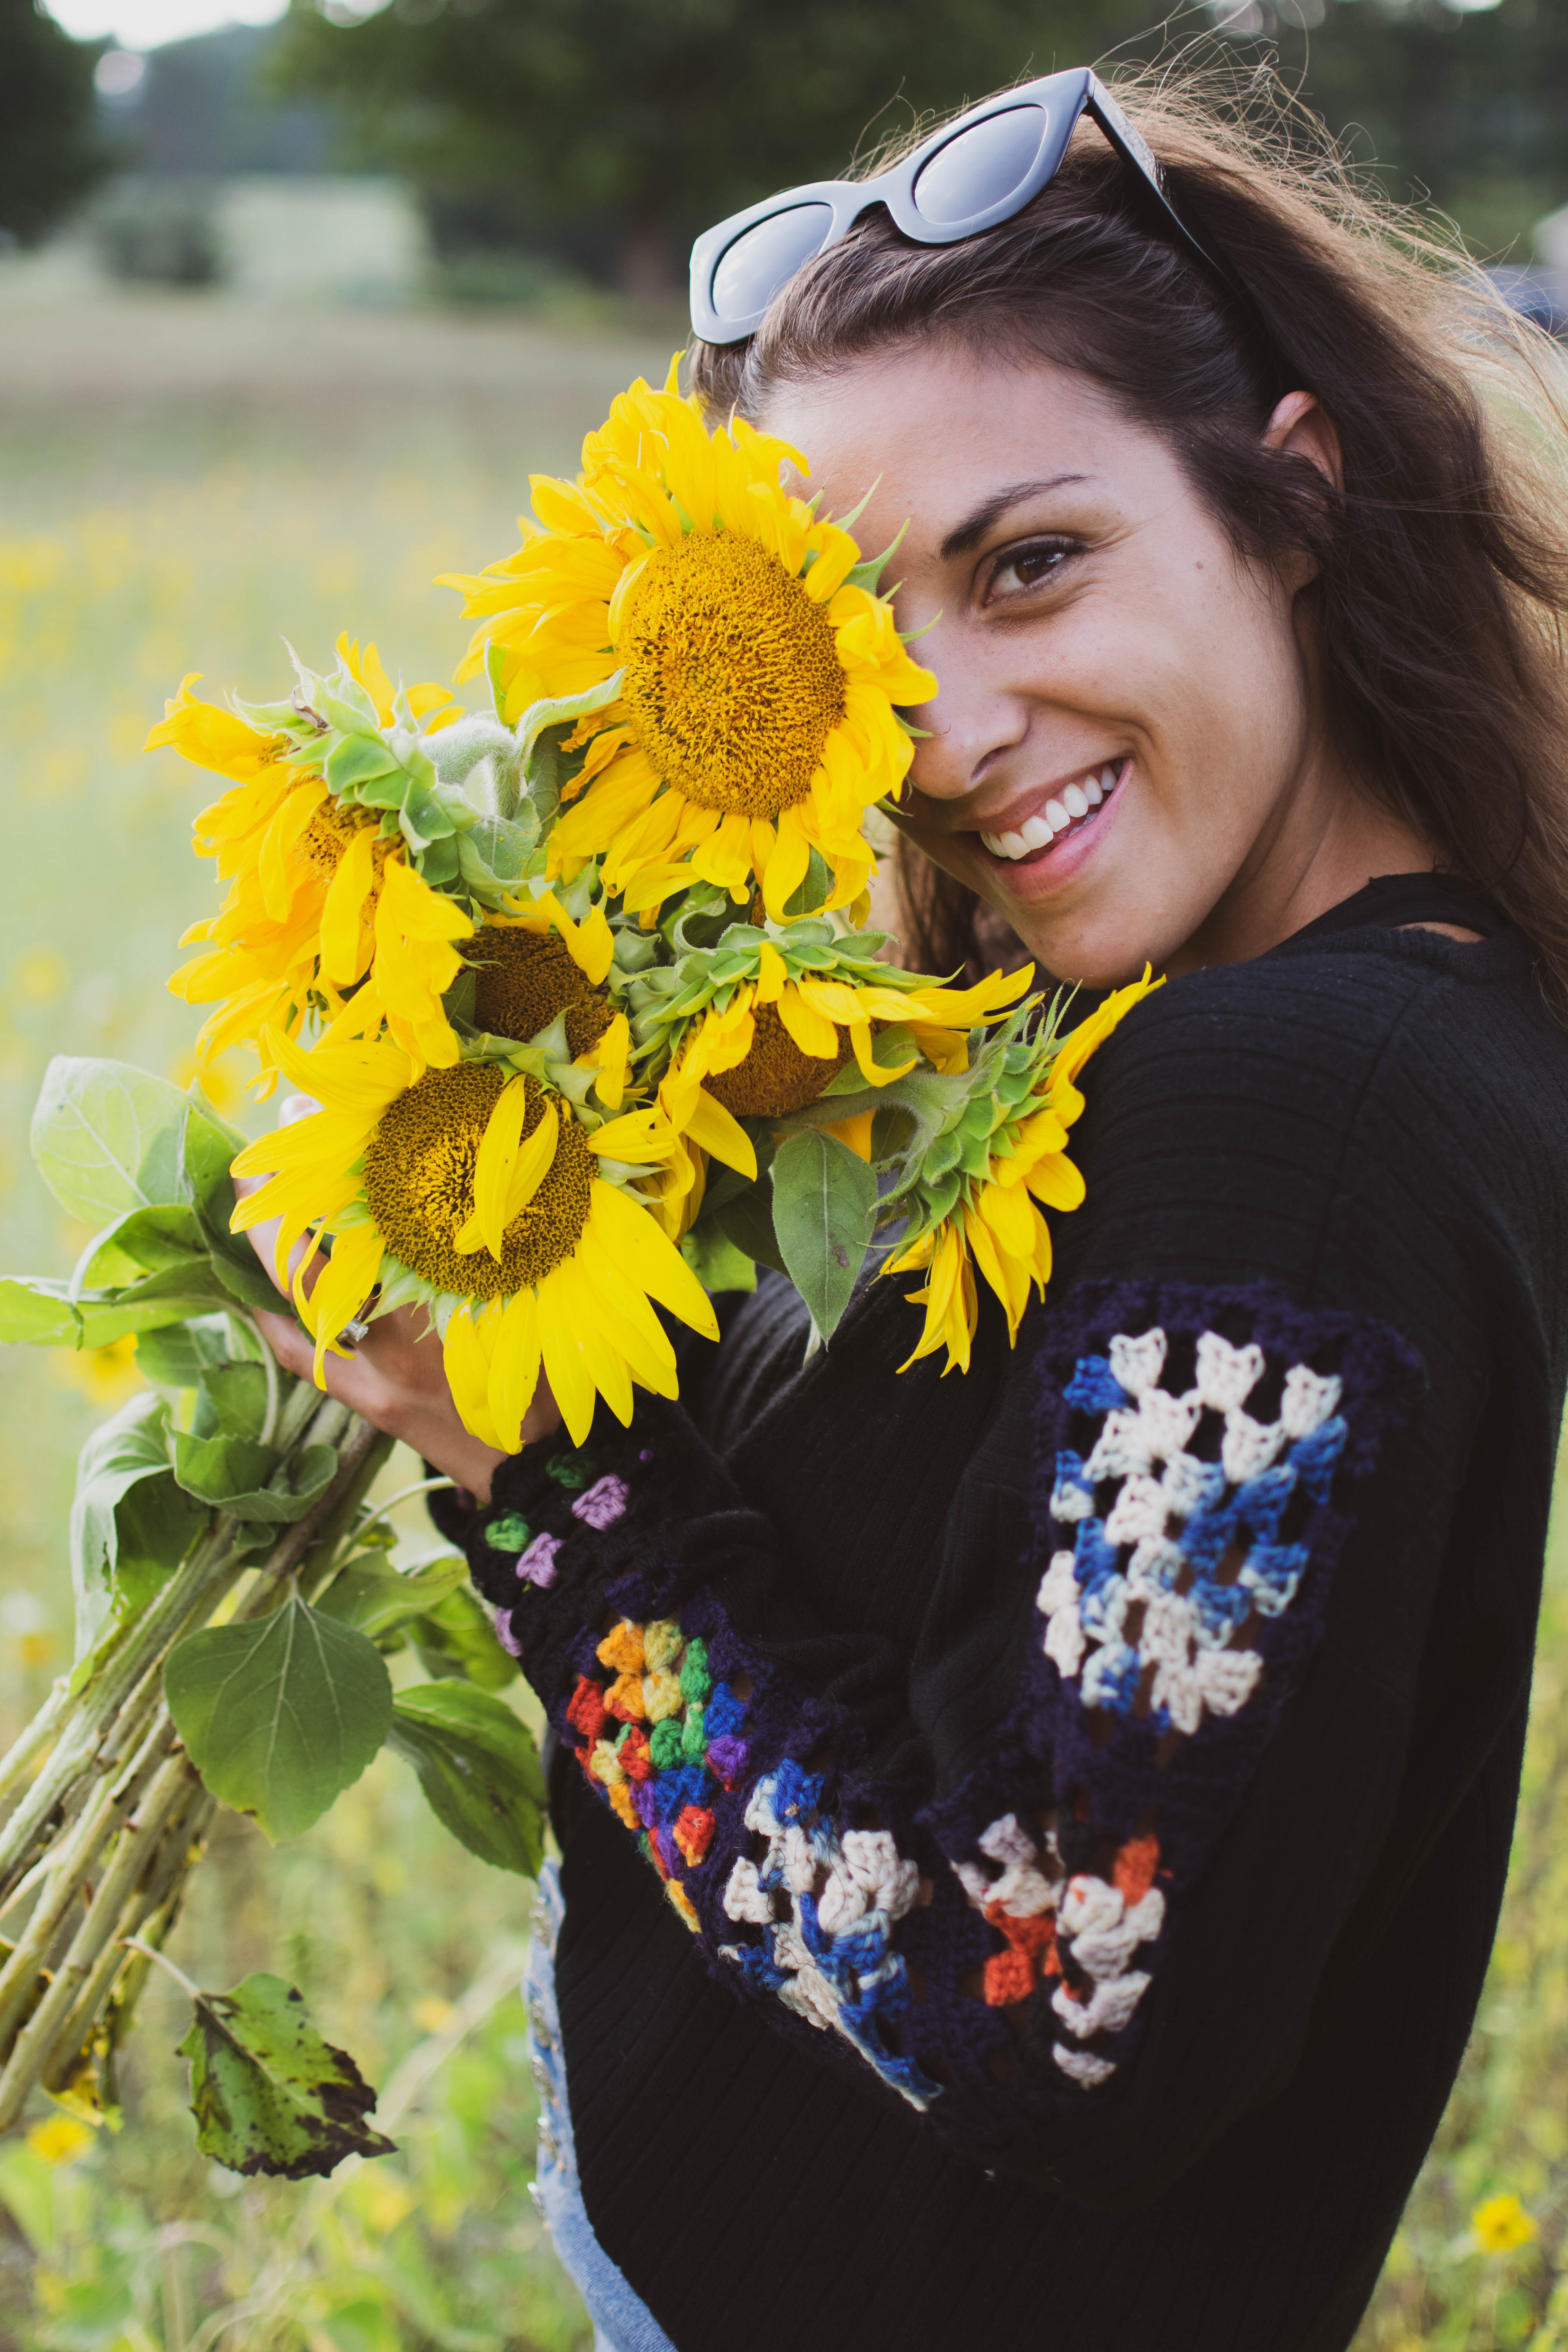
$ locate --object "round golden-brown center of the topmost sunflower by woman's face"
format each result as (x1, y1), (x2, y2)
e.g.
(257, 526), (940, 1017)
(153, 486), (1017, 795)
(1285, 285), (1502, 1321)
(621, 532), (844, 816)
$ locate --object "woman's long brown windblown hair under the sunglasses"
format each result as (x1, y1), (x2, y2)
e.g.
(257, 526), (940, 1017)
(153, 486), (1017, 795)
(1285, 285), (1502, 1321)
(691, 73), (1568, 1018)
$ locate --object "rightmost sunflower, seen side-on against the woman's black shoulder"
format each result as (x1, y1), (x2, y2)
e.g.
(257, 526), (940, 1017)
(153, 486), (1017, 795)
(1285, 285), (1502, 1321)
(882, 969), (1161, 1371)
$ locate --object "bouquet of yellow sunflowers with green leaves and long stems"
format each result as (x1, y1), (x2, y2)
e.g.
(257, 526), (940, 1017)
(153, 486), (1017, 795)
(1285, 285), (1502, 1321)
(0, 362), (1147, 2171)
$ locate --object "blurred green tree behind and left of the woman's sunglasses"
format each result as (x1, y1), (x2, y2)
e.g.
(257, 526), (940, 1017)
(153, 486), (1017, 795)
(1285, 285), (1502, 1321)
(270, 0), (1128, 289)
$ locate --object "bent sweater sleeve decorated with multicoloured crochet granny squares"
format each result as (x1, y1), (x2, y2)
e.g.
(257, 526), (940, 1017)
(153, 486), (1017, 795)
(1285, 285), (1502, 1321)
(444, 1284), (1410, 2171)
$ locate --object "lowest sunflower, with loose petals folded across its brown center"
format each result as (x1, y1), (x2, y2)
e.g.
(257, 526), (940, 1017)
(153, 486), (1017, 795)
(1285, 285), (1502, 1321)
(233, 1037), (717, 1451)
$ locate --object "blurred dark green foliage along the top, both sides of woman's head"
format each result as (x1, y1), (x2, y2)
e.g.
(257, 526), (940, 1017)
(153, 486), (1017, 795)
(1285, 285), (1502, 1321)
(275, 0), (1568, 292)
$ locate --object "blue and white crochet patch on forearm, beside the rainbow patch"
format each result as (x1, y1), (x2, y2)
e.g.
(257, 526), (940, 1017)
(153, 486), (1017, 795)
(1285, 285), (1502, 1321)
(722, 1757), (940, 2107)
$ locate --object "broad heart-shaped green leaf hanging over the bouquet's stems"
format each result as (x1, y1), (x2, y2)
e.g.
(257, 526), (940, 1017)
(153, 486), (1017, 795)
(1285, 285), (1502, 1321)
(165, 1592), (392, 1844)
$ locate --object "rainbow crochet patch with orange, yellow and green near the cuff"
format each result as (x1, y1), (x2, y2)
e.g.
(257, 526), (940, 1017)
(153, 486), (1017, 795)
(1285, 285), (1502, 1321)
(566, 1609), (748, 1933)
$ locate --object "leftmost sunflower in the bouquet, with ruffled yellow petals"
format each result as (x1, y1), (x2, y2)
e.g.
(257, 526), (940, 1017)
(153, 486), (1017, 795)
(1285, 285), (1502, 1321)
(160, 637), (472, 1094)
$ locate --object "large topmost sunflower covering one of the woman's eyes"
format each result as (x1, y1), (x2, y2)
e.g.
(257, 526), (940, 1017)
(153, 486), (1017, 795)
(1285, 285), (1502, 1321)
(435, 381), (936, 920)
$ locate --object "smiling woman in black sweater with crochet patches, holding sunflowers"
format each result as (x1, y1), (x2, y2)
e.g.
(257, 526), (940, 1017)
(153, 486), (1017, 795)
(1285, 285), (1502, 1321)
(245, 69), (1568, 2352)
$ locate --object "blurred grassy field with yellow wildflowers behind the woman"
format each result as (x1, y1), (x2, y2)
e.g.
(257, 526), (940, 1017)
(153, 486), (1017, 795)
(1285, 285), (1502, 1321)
(0, 270), (1568, 2352)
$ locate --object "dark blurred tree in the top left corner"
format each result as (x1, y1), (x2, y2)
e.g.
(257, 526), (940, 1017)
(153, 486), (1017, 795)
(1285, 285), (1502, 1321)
(0, 0), (111, 245)
